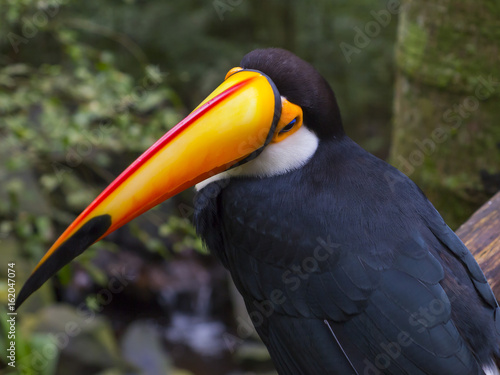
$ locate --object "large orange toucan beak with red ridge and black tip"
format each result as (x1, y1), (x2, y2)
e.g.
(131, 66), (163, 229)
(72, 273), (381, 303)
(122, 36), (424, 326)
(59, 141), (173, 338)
(16, 68), (287, 307)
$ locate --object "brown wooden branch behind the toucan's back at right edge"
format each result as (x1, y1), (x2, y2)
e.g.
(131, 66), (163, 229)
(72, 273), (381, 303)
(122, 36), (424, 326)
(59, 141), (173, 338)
(457, 192), (500, 300)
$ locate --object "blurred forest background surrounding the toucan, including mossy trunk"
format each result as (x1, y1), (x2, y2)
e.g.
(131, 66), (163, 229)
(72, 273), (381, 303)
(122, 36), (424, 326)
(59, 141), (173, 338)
(0, 0), (500, 375)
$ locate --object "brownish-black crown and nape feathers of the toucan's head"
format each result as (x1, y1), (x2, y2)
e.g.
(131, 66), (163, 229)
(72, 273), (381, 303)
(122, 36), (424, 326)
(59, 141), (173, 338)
(240, 48), (344, 139)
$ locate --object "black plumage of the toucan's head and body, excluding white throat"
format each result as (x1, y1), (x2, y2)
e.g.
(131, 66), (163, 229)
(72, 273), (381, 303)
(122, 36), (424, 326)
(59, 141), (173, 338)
(195, 49), (500, 375)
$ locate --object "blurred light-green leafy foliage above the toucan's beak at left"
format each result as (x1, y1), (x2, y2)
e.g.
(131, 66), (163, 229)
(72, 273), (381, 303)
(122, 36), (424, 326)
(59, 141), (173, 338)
(0, 1), (186, 264)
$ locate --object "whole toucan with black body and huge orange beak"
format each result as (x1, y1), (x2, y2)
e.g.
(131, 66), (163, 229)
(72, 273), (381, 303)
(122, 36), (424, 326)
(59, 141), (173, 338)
(17, 48), (500, 375)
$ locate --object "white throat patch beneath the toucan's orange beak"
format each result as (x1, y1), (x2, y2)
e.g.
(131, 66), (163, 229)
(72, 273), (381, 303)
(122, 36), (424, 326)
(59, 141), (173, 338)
(196, 124), (319, 190)
